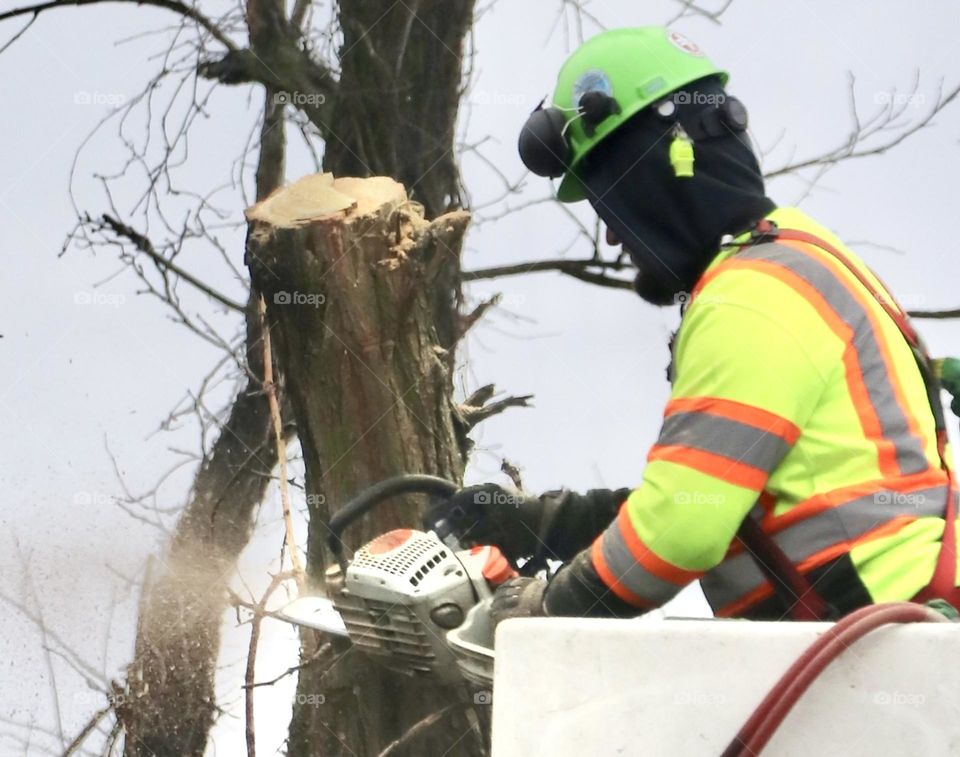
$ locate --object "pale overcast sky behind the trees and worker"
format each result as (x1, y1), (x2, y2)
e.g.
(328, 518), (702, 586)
(0, 0), (960, 755)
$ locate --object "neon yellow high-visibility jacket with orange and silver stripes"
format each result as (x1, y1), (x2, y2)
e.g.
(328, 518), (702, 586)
(591, 208), (947, 617)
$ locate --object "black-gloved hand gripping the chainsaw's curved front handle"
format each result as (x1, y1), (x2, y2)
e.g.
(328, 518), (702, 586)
(427, 484), (542, 563)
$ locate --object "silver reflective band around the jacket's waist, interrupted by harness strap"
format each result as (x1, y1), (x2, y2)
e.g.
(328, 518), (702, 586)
(700, 486), (947, 610)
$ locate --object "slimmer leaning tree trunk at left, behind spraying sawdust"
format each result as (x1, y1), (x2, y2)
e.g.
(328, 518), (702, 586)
(117, 91), (284, 757)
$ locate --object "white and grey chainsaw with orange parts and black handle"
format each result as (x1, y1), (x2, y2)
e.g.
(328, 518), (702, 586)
(277, 474), (532, 684)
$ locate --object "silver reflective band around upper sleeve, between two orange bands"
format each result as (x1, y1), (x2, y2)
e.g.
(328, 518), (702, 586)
(657, 412), (790, 473)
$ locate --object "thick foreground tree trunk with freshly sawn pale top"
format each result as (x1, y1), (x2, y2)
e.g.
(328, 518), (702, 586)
(247, 174), (479, 755)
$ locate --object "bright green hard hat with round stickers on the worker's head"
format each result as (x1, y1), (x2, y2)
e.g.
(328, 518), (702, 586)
(553, 26), (728, 202)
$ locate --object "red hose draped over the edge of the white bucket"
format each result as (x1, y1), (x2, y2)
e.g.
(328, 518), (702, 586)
(722, 602), (946, 757)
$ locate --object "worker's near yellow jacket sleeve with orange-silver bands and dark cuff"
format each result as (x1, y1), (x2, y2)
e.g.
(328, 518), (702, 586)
(545, 302), (826, 616)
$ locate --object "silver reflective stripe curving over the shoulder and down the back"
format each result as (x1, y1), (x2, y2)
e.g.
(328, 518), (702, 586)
(738, 244), (929, 475)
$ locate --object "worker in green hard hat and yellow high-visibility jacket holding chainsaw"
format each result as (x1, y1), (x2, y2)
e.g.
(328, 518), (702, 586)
(432, 27), (957, 622)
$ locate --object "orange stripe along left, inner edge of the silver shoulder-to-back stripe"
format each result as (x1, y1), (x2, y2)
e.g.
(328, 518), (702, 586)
(719, 258), (900, 476)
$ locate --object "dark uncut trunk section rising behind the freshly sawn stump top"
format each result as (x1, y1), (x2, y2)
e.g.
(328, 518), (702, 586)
(318, 0), (475, 218)
